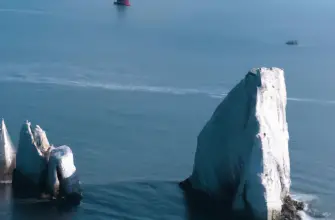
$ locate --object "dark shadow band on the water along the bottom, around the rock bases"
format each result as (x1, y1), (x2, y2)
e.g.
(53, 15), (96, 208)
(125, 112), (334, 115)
(0, 180), (326, 220)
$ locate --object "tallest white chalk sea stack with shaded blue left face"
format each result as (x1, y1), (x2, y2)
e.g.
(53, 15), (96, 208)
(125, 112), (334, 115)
(181, 68), (290, 219)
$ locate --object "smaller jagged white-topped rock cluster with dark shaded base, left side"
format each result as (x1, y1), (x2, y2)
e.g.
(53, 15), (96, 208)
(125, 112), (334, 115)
(12, 121), (82, 205)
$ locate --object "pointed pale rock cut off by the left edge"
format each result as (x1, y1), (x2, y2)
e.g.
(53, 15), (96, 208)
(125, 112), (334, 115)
(0, 119), (16, 182)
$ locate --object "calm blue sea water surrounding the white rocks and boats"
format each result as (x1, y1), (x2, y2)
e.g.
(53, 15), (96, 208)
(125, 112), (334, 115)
(0, 0), (335, 219)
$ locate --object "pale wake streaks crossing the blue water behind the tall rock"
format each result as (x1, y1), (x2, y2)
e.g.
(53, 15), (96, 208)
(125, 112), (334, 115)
(0, 62), (335, 105)
